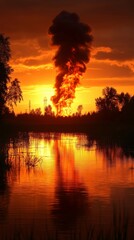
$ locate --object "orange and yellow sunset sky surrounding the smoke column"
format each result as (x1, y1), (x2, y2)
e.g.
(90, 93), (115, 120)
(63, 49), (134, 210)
(0, 0), (134, 112)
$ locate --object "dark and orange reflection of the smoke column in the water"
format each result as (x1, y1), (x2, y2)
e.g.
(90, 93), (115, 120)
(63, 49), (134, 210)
(52, 141), (89, 235)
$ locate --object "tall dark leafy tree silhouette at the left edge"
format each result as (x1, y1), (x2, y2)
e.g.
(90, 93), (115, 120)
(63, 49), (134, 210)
(0, 34), (22, 116)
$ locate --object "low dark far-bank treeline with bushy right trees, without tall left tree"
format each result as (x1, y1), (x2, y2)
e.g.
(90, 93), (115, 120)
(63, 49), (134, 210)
(3, 87), (134, 139)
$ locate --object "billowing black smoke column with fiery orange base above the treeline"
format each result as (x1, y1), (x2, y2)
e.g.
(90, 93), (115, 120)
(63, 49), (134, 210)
(48, 11), (93, 115)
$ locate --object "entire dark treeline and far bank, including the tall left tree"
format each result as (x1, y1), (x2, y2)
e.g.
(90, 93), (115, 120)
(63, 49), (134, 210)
(0, 34), (134, 139)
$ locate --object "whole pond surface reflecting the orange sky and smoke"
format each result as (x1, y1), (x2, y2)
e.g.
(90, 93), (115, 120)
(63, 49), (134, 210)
(0, 133), (134, 240)
